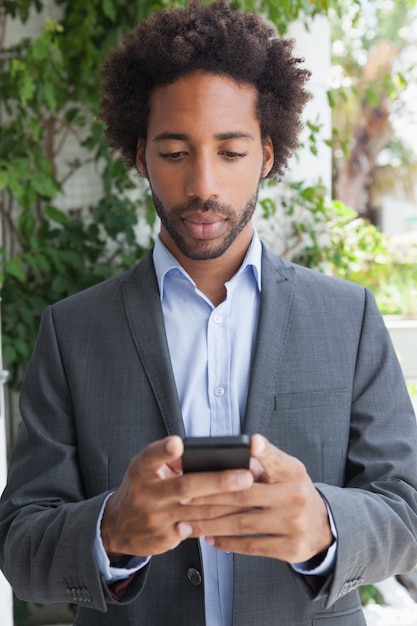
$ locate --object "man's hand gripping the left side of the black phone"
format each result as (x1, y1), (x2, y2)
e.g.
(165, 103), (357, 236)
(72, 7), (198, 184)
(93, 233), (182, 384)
(101, 436), (253, 563)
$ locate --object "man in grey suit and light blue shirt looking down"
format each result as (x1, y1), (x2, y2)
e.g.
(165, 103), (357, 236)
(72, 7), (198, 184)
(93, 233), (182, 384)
(0, 1), (417, 626)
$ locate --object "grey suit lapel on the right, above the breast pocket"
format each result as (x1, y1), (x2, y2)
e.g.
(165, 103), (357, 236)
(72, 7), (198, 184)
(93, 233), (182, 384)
(243, 248), (295, 433)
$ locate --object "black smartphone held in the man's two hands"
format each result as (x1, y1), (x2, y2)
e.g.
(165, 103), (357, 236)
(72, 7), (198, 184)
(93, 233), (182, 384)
(182, 435), (250, 474)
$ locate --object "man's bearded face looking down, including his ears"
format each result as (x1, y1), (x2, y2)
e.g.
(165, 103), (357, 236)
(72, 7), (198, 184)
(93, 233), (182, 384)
(137, 72), (273, 260)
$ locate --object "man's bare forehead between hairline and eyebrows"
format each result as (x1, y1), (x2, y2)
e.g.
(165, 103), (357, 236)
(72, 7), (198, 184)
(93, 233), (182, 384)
(148, 72), (260, 138)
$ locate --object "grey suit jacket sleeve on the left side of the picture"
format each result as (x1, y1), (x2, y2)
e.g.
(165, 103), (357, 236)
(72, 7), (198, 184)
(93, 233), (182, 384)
(0, 309), (148, 611)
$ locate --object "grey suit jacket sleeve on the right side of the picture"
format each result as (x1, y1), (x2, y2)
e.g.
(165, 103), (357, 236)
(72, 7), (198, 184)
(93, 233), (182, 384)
(317, 292), (417, 606)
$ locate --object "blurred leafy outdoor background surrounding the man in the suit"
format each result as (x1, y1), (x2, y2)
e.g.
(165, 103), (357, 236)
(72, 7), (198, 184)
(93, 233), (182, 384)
(0, 0), (417, 626)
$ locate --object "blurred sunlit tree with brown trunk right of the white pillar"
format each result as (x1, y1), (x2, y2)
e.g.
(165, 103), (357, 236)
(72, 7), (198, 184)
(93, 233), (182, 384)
(328, 0), (417, 215)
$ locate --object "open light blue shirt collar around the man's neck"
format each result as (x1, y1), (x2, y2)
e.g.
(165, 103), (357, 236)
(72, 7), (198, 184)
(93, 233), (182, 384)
(153, 230), (262, 300)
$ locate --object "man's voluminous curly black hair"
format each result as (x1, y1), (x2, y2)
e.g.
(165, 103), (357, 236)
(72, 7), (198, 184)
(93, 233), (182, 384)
(100, 0), (310, 178)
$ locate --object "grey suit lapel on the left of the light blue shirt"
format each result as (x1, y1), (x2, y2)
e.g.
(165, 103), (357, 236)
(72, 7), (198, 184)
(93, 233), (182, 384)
(122, 253), (185, 437)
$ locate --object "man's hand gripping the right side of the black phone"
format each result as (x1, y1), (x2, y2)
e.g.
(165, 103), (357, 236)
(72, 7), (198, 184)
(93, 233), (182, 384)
(180, 435), (334, 563)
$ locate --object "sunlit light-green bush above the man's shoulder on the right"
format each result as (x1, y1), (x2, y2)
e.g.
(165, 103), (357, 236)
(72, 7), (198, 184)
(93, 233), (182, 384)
(257, 182), (417, 318)
